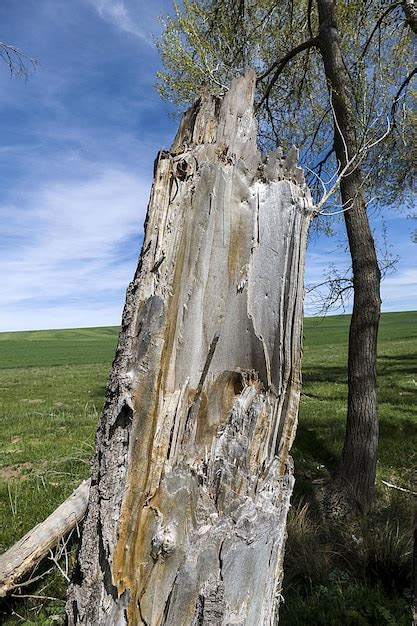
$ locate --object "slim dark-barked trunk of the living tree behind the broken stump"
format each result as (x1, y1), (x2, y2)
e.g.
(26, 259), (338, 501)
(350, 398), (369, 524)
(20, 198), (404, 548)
(317, 0), (381, 511)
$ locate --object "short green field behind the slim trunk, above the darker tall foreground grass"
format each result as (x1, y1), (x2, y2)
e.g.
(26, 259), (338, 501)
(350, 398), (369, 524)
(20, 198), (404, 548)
(292, 312), (417, 489)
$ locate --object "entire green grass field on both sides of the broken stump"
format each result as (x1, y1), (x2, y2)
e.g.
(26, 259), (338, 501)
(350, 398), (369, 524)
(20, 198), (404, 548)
(0, 312), (417, 626)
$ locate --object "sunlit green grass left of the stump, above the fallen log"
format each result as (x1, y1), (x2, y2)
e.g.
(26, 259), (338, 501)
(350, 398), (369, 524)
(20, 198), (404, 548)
(0, 328), (118, 551)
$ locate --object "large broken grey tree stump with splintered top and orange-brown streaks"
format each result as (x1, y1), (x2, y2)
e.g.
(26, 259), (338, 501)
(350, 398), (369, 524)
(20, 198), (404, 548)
(67, 72), (313, 626)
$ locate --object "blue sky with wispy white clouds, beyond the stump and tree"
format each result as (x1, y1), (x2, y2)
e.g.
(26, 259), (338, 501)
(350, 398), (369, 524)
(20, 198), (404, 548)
(0, 0), (417, 330)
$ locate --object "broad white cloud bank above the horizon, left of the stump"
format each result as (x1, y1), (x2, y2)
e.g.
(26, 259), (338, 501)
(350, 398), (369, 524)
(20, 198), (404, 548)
(0, 167), (150, 330)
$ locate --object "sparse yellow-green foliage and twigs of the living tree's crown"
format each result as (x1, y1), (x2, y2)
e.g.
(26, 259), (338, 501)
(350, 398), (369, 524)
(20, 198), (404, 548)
(157, 0), (415, 204)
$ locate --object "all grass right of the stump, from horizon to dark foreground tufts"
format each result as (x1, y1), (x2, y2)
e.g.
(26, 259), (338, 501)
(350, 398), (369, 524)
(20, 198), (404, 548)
(280, 312), (417, 626)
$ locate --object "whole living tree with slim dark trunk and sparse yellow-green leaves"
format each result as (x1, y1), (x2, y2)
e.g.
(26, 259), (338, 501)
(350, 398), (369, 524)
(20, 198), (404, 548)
(159, 0), (415, 511)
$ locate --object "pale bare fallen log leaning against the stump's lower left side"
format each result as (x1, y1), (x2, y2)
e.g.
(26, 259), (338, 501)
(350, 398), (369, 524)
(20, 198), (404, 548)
(0, 480), (90, 597)
